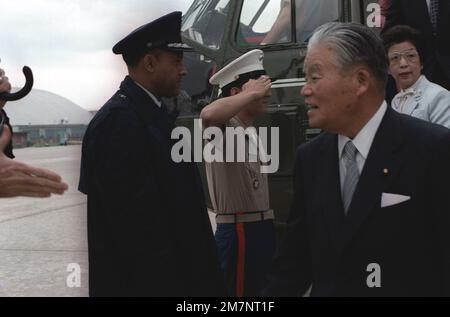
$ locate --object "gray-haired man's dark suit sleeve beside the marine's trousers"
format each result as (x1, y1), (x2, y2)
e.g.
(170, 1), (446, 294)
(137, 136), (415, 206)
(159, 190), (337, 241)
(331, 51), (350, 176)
(263, 146), (312, 297)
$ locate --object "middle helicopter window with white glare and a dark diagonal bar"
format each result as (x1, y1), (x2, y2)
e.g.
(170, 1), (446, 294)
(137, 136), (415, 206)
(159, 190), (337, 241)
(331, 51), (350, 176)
(237, 0), (292, 46)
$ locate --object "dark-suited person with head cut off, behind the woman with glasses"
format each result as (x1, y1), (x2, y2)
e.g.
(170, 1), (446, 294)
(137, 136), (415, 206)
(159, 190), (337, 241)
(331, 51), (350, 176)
(383, 0), (450, 90)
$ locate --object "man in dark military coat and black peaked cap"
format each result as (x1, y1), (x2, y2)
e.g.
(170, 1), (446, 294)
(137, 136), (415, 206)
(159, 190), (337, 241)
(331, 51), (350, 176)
(79, 12), (225, 296)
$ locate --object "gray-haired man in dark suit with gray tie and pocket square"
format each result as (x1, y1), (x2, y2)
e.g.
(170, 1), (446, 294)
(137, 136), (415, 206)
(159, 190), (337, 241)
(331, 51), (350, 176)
(264, 23), (450, 296)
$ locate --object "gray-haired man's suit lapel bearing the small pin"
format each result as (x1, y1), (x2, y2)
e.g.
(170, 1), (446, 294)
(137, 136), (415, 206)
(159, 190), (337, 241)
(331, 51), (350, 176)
(342, 108), (402, 247)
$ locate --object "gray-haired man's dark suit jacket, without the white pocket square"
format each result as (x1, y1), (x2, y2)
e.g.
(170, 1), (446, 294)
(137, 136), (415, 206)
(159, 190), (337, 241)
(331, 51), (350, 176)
(264, 109), (450, 296)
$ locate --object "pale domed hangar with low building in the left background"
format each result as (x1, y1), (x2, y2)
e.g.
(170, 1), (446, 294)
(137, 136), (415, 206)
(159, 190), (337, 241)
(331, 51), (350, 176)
(5, 89), (93, 147)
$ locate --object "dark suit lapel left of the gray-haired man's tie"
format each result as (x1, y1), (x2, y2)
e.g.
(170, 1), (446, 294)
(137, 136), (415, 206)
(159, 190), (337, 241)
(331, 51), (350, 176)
(316, 134), (344, 248)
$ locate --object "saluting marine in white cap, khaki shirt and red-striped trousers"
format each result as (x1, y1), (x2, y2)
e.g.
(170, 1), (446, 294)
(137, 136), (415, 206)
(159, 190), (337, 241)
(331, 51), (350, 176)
(200, 50), (275, 296)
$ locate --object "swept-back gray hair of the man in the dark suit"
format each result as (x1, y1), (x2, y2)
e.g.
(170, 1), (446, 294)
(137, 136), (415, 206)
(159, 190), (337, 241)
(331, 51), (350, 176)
(308, 22), (389, 88)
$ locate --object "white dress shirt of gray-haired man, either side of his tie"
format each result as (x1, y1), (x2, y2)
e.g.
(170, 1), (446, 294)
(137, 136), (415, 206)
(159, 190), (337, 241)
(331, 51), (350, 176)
(338, 101), (387, 188)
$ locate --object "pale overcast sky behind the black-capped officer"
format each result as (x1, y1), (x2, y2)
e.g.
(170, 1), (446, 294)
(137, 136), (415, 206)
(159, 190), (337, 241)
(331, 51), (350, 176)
(0, 0), (192, 110)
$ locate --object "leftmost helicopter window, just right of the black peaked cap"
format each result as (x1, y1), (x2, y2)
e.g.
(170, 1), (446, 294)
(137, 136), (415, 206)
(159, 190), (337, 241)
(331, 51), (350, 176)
(181, 0), (230, 49)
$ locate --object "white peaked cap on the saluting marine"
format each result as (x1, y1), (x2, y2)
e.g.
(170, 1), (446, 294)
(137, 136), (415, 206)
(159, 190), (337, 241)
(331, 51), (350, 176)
(209, 50), (264, 89)
